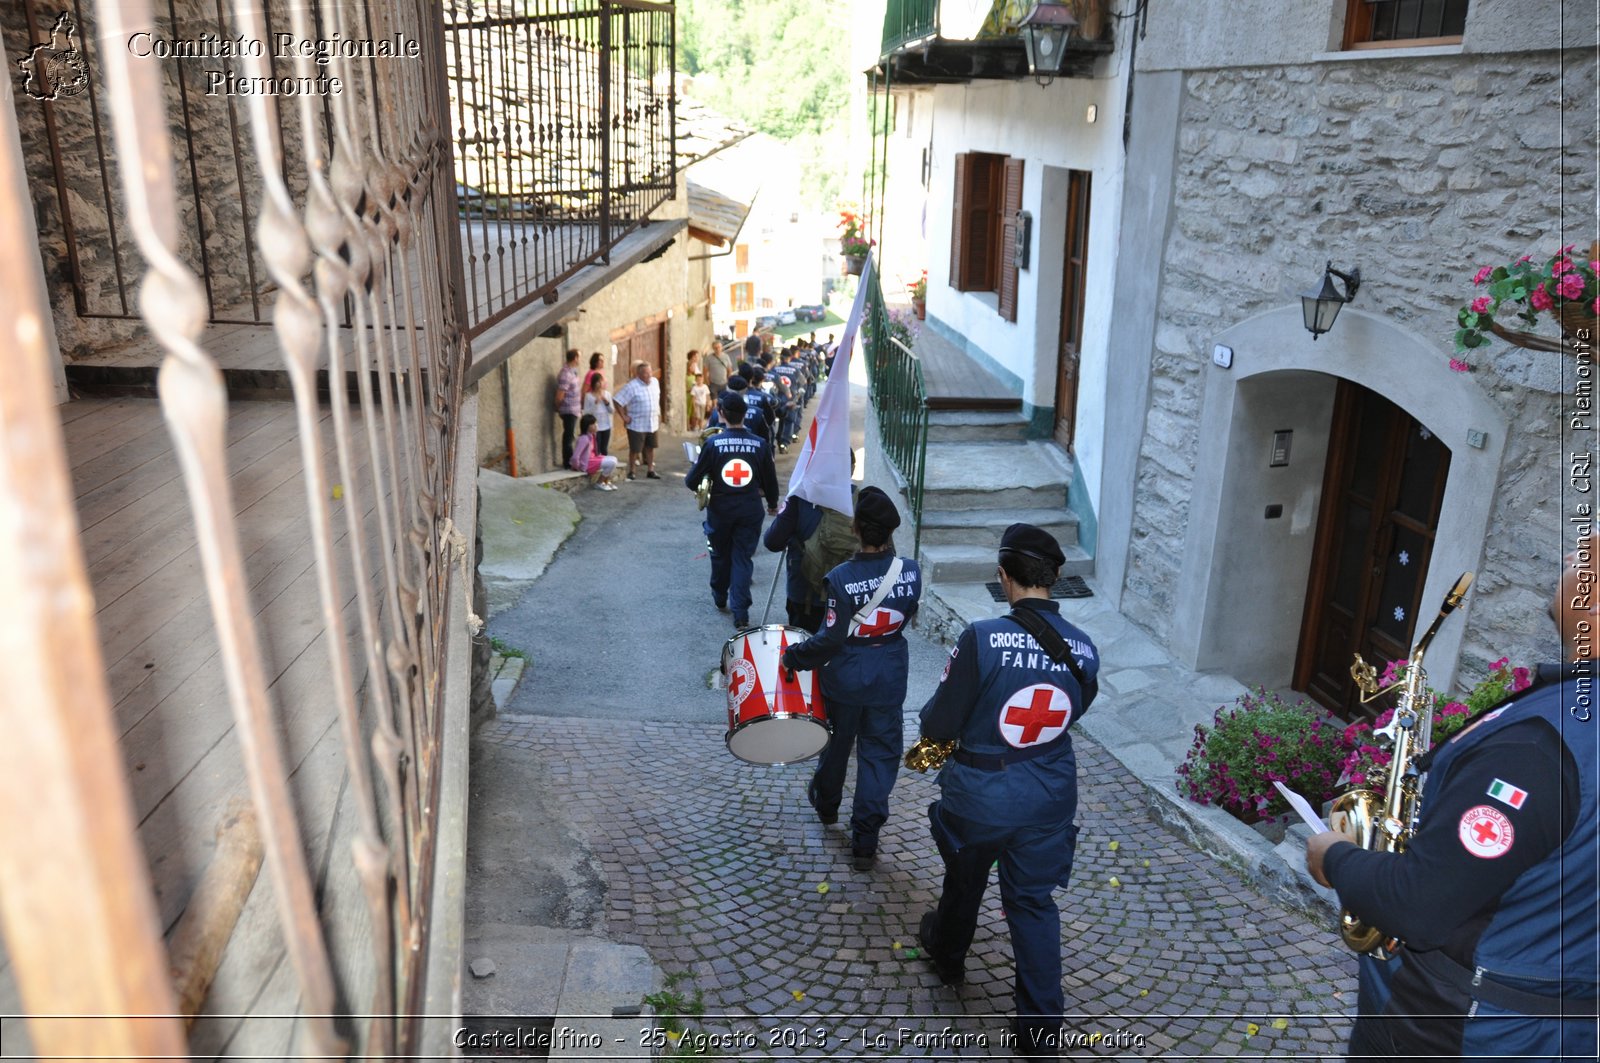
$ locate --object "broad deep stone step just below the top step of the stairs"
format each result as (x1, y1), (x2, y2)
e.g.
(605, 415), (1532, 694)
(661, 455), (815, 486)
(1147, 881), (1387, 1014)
(923, 440), (1072, 511)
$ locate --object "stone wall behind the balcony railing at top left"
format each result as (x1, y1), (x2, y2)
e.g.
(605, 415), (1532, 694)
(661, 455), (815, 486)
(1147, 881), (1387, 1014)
(0, 0), (371, 362)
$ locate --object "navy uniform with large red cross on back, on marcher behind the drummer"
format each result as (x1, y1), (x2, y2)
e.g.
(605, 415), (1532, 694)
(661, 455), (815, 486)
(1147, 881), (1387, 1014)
(922, 597), (1099, 1055)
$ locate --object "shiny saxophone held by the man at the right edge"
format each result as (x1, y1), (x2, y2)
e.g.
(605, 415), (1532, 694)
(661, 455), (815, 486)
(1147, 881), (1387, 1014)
(1328, 572), (1472, 959)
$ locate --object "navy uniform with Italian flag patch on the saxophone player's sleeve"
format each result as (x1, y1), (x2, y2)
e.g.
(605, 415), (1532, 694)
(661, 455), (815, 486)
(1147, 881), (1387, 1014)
(1323, 663), (1600, 1060)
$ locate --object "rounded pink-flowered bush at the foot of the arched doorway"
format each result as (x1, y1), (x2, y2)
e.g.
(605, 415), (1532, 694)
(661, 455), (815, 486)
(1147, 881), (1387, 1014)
(1178, 687), (1346, 820)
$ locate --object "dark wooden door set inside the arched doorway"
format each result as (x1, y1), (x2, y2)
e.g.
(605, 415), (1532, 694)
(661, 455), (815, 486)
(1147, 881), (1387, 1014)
(1294, 381), (1450, 720)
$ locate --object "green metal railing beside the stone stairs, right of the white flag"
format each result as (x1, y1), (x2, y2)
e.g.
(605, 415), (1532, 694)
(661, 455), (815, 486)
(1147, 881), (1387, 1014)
(862, 269), (928, 557)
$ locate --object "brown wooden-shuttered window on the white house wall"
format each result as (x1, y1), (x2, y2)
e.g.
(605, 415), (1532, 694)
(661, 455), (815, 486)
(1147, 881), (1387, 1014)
(950, 152), (1022, 322)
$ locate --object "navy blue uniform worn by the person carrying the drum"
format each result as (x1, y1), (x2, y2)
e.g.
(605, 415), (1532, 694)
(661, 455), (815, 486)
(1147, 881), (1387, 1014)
(784, 551), (922, 853)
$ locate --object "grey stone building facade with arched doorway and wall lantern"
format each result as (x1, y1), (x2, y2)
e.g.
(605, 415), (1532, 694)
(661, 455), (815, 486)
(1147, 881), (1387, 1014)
(1098, 0), (1600, 710)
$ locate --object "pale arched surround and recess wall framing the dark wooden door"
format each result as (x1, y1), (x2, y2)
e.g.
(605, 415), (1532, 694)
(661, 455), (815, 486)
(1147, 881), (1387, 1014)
(1171, 306), (1507, 688)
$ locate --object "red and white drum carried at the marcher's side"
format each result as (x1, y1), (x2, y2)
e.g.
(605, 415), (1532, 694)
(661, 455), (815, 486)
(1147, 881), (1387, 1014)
(722, 624), (832, 764)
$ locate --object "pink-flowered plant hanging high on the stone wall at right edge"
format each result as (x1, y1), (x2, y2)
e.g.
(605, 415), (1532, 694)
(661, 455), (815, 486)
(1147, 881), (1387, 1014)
(1450, 243), (1600, 373)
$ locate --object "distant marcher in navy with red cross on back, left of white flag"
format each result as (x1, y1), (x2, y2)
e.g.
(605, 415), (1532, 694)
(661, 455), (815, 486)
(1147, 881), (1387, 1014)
(683, 392), (778, 628)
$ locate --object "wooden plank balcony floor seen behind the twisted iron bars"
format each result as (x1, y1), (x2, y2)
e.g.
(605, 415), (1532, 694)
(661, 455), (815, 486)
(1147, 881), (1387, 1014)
(0, 397), (406, 1058)
